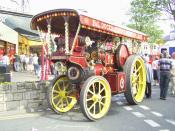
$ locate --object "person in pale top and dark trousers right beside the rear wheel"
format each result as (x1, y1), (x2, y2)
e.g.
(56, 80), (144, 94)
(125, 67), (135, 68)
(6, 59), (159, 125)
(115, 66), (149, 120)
(145, 59), (153, 98)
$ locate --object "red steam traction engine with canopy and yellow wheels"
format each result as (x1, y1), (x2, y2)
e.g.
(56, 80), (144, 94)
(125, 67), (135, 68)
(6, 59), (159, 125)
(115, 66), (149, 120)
(31, 9), (147, 121)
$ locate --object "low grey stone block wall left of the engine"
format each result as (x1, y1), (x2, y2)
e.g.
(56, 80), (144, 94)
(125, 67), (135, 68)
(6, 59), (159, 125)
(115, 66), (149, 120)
(0, 81), (49, 114)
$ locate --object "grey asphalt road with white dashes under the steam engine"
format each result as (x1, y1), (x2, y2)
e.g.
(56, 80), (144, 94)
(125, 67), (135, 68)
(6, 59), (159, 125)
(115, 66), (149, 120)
(0, 87), (175, 131)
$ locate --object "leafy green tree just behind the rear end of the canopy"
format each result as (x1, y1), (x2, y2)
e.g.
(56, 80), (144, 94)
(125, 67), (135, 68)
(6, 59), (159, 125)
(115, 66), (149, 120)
(128, 0), (163, 43)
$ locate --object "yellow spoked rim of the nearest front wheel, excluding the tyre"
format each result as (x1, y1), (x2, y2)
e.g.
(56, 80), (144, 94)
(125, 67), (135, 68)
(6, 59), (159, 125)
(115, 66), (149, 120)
(85, 79), (111, 119)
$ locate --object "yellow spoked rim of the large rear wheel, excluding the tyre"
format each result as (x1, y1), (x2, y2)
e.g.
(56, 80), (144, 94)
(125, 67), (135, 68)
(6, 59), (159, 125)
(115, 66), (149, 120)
(131, 58), (146, 102)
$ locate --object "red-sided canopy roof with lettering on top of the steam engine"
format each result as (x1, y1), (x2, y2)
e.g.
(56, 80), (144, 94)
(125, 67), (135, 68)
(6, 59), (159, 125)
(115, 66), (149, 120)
(31, 9), (148, 41)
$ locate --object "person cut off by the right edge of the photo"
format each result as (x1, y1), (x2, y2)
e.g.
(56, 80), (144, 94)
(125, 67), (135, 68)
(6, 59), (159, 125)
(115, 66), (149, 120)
(170, 52), (175, 95)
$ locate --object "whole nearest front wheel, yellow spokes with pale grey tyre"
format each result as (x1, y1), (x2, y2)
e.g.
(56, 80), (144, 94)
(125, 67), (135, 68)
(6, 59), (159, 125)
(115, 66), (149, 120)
(80, 76), (111, 121)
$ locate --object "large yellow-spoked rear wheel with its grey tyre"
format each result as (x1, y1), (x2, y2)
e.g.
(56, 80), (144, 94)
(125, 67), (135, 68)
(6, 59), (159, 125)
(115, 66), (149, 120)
(124, 55), (146, 105)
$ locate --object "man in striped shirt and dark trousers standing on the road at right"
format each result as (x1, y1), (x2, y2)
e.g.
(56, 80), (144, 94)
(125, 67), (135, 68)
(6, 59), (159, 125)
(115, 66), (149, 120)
(158, 51), (172, 100)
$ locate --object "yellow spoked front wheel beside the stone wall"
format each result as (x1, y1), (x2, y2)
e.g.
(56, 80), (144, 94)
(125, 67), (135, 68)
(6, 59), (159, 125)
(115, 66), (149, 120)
(48, 76), (77, 113)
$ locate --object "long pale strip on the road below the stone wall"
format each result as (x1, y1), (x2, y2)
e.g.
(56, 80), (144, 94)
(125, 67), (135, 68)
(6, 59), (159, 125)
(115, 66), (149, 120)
(0, 114), (41, 120)
